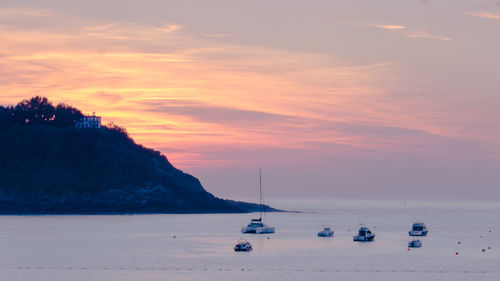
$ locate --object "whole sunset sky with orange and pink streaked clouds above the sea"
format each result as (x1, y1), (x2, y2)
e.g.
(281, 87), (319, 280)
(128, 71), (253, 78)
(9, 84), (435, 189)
(0, 0), (500, 202)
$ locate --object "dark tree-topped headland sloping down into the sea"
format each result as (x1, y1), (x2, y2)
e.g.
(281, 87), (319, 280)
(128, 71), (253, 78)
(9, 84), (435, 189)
(0, 97), (276, 214)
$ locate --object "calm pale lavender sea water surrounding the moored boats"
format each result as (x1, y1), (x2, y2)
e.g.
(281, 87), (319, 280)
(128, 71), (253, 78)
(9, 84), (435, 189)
(0, 200), (500, 281)
